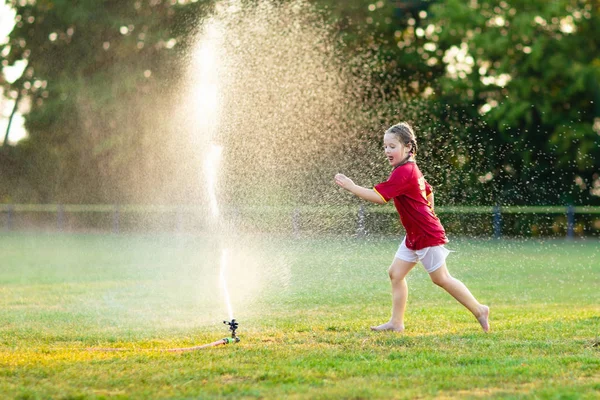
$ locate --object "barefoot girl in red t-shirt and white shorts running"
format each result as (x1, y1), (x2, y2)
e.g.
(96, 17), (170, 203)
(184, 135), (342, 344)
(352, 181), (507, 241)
(335, 122), (490, 332)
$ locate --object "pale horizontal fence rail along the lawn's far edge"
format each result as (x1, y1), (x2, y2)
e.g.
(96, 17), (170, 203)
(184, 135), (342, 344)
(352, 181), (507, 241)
(0, 204), (600, 238)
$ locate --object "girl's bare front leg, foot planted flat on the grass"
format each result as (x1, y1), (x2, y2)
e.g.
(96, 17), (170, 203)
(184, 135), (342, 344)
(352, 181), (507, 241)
(371, 258), (417, 332)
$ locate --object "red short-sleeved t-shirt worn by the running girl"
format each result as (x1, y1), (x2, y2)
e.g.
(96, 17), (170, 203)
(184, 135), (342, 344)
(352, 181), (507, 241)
(374, 162), (448, 250)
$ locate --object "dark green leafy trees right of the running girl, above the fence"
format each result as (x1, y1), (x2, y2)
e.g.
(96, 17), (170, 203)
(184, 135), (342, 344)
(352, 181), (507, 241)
(430, 0), (600, 204)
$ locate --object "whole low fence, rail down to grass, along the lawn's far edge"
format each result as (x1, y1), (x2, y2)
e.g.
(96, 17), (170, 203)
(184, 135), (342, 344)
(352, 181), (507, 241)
(0, 204), (600, 238)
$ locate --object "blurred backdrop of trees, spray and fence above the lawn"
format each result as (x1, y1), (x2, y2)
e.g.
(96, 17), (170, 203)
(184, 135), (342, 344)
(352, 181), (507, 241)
(0, 0), (600, 236)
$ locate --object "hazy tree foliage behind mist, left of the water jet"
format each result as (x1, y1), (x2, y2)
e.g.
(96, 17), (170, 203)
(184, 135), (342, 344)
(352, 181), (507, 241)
(0, 0), (211, 202)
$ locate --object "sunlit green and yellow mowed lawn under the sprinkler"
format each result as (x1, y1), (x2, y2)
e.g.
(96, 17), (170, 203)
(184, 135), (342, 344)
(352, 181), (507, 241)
(0, 233), (600, 399)
